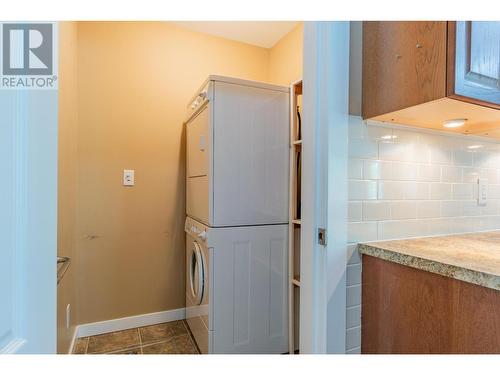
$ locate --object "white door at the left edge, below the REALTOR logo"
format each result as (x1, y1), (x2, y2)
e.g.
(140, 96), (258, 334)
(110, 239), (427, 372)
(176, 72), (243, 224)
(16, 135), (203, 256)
(0, 24), (57, 353)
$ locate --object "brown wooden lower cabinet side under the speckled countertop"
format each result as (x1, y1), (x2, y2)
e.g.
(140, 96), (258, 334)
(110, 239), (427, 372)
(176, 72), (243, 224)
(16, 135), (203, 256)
(361, 255), (500, 354)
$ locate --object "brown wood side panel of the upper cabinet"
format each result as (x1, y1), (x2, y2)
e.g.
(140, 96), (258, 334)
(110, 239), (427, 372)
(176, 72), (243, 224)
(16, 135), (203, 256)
(362, 22), (447, 118)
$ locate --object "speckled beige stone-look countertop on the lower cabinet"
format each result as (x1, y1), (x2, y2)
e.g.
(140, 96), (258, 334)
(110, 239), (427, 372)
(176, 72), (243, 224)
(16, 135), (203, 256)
(359, 231), (500, 290)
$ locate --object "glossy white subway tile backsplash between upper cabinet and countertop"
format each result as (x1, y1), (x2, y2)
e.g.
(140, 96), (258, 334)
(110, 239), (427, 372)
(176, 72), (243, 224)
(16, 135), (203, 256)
(346, 116), (500, 353)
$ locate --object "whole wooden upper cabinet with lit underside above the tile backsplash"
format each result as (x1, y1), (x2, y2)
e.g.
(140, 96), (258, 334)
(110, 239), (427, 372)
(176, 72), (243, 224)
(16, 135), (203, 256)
(362, 21), (500, 138)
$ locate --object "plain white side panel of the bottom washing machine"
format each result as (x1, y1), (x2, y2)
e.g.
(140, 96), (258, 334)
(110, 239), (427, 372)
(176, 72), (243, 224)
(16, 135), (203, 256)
(209, 224), (288, 354)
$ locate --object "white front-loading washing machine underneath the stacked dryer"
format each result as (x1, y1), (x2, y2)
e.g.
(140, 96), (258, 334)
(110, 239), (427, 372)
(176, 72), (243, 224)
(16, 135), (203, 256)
(185, 217), (288, 354)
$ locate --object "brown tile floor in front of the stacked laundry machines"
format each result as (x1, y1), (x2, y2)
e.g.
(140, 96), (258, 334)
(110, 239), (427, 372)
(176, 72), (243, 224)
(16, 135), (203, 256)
(73, 320), (199, 354)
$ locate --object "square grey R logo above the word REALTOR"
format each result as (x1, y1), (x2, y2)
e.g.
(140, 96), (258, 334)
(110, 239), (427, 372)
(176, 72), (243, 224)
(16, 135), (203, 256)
(2, 23), (52, 75)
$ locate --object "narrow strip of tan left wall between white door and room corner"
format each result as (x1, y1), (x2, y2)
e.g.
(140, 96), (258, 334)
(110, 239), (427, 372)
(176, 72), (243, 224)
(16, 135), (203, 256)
(57, 22), (78, 353)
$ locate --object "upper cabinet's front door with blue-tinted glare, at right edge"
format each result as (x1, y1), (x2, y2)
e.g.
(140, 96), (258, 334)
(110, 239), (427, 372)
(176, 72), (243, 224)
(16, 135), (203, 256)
(450, 21), (500, 107)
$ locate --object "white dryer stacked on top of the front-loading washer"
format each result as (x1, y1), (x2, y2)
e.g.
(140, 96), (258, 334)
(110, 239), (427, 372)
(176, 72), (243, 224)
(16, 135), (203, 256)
(185, 76), (289, 227)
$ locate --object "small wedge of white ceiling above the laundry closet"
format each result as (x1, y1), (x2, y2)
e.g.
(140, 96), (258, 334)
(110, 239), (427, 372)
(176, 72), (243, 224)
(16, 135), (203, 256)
(173, 21), (298, 48)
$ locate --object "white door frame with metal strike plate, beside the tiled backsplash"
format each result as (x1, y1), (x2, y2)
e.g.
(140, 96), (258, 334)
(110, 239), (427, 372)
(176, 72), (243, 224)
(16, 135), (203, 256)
(300, 22), (349, 353)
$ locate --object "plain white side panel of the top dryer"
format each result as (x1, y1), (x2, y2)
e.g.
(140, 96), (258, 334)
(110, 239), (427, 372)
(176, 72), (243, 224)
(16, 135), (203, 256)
(212, 82), (290, 226)
